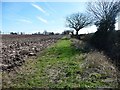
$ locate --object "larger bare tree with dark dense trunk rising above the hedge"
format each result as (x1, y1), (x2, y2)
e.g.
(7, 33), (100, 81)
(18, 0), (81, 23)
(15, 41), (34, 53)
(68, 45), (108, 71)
(88, 0), (120, 31)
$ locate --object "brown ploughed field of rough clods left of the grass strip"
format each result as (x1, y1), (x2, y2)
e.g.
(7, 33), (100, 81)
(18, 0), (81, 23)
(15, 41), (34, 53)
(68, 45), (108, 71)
(0, 35), (62, 70)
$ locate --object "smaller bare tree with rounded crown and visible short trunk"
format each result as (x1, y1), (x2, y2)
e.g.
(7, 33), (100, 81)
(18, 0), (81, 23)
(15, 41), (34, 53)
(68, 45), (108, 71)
(66, 13), (92, 35)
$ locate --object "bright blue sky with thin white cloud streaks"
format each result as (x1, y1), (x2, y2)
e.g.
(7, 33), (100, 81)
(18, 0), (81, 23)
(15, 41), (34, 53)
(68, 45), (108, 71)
(0, 2), (118, 34)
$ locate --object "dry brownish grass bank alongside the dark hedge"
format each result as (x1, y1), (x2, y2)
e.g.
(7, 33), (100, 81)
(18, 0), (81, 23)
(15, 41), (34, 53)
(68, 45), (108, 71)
(72, 39), (118, 87)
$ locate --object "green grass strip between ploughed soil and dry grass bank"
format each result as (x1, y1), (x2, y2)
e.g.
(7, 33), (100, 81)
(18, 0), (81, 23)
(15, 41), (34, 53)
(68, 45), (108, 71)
(1, 39), (114, 88)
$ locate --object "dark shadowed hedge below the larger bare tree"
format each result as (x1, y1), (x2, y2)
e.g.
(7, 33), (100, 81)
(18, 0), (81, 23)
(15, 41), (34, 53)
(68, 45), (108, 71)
(90, 31), (120, 70)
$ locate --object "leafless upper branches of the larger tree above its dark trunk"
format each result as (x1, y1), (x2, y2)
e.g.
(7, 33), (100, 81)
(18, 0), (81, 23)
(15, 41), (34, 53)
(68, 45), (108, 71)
(88, 0), (120, 21)
